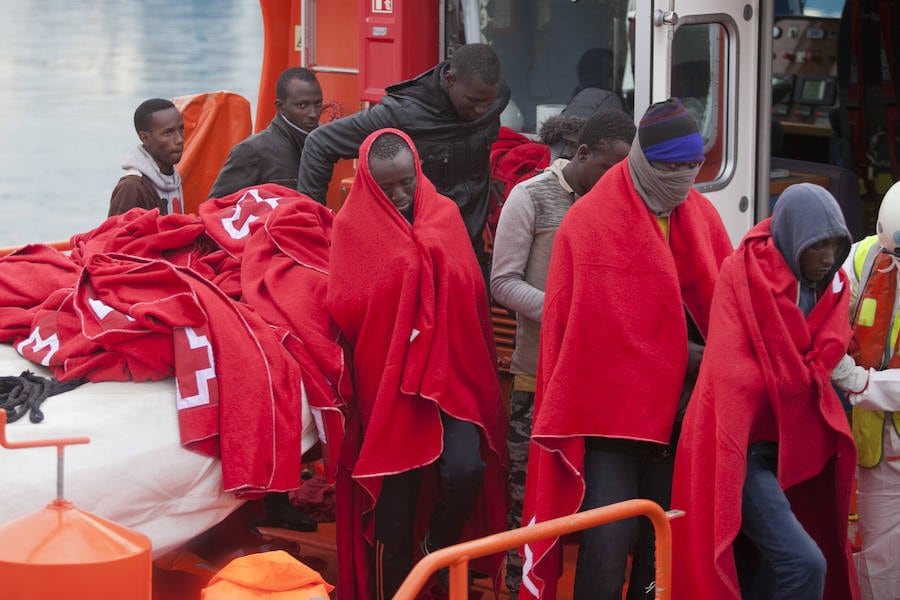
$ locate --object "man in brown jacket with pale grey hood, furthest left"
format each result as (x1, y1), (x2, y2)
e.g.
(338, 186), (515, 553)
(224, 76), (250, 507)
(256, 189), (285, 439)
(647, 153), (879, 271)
(107, 98), (184, 217)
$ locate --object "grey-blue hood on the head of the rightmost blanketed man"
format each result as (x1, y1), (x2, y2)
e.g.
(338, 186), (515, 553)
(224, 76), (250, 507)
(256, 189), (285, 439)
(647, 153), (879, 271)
(771, 183), (852, 314)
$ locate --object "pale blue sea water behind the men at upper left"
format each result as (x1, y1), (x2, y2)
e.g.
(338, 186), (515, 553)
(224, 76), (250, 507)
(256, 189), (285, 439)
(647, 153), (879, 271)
(0, 0), (263, 248)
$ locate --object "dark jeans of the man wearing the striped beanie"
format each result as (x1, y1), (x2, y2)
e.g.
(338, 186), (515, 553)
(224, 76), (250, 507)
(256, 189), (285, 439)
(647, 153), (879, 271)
(573, 446), (675, 600)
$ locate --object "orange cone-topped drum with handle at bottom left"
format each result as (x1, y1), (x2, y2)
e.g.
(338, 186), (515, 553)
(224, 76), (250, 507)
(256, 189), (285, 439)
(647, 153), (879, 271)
(0, 409), (152, 600)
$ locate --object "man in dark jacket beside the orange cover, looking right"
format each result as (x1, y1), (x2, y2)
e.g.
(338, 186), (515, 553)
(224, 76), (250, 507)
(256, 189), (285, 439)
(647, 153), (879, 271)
(209, 67), (322, 198)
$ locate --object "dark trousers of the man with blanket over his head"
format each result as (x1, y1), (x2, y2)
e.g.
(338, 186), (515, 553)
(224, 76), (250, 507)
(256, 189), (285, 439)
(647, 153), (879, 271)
(375, 413), (485, 598)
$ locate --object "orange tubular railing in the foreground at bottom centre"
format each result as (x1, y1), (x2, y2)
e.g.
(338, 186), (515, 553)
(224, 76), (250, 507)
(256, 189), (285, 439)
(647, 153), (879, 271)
(394, 499), (684, 600)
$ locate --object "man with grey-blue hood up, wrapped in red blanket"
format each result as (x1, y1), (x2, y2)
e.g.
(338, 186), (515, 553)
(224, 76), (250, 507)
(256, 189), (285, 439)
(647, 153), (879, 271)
(672, 184), (859, 600)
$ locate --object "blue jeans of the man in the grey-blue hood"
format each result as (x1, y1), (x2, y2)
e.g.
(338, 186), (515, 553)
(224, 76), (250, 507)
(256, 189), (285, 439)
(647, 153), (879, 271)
(735, 443), (825, 600)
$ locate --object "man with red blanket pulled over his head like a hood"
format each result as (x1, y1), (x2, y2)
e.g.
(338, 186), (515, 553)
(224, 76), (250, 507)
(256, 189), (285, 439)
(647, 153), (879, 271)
(327, 129), (506, 600)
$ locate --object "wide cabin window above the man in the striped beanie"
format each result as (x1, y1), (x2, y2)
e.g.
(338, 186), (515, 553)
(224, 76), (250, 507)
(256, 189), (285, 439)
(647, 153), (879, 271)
(444, 0), (634, 133)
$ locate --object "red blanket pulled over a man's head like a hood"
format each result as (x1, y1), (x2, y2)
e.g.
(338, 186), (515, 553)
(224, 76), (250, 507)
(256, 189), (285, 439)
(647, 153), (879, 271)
(327, 130), (506, 599)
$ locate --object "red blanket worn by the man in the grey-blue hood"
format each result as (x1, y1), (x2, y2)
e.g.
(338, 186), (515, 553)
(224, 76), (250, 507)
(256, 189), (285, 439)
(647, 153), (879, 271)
(672, 220), (859, 600)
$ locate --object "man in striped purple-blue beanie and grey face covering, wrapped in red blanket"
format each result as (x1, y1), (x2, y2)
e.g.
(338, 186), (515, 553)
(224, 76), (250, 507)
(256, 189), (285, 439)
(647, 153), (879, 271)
(519, 99), (732, 600)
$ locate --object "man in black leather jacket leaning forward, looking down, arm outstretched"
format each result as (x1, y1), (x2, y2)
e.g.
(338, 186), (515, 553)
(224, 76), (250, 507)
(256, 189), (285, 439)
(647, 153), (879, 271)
(297, 44), (510, 264)
